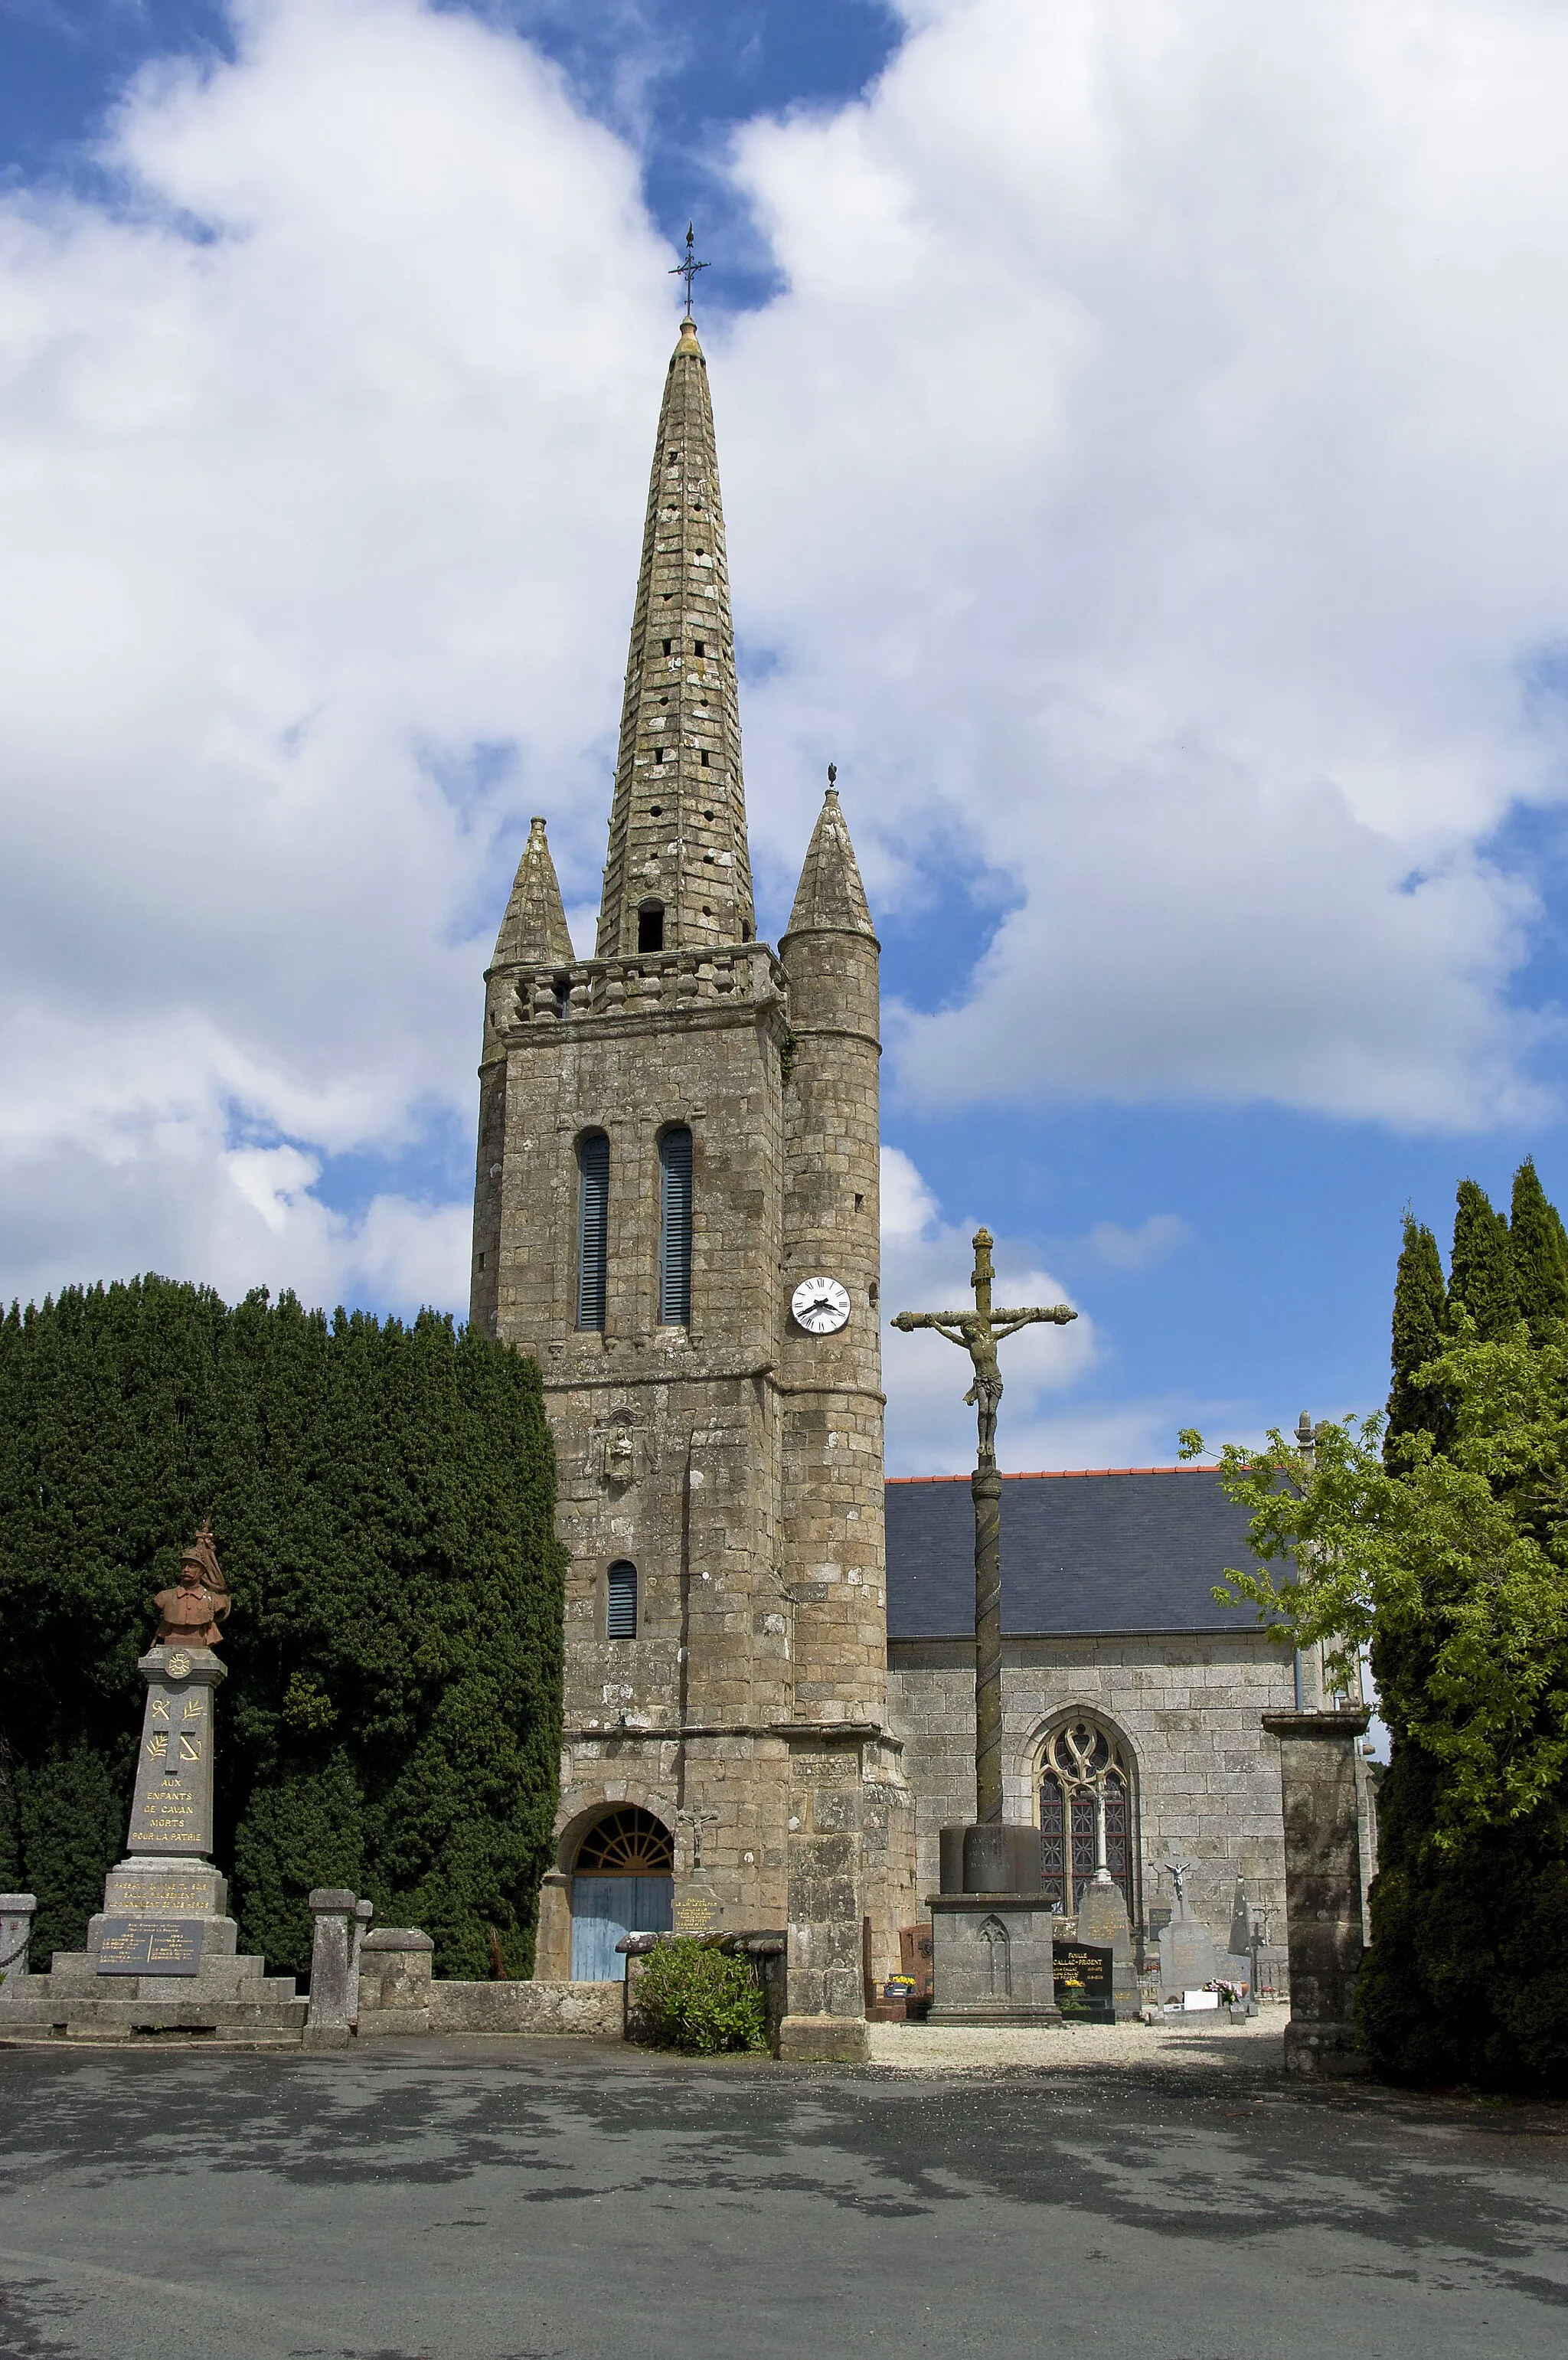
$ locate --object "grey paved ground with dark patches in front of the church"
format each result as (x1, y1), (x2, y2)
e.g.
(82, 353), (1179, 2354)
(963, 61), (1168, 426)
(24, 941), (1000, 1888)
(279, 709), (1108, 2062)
(0, 2018), (1568, 2360)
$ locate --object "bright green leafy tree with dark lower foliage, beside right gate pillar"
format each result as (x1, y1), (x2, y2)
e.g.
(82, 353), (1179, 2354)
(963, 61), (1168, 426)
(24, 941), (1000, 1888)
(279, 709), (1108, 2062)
(1186, 1307), (1568, 2094)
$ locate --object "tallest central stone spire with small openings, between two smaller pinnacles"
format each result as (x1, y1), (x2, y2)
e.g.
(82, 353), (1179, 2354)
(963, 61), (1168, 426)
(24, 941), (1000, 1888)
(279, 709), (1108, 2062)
(599, 319), (757, 958)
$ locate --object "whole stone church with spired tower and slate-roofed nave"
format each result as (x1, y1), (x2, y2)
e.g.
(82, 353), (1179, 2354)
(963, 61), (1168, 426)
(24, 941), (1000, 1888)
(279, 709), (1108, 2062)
(472, 316), (1339, 2055)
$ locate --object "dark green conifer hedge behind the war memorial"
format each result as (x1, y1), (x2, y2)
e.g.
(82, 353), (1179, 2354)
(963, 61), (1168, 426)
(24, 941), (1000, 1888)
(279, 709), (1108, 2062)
(0, 1276), (566, 1976)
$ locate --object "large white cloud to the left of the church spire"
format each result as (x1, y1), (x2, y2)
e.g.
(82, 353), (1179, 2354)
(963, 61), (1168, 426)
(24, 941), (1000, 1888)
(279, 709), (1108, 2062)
(0, 0), (670, 1303)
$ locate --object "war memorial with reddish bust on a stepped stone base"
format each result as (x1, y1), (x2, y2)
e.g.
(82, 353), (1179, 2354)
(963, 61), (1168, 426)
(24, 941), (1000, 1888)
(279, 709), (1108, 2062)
(0, 1525), (306, 2046)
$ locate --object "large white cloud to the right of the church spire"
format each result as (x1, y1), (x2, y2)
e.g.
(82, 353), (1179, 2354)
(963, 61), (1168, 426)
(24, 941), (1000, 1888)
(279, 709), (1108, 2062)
(719, 0), (1568, 1126)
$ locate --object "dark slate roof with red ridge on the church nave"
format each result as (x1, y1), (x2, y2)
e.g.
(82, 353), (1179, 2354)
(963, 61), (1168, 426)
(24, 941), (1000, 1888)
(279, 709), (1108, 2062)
(887, 1468), (1256, 1638)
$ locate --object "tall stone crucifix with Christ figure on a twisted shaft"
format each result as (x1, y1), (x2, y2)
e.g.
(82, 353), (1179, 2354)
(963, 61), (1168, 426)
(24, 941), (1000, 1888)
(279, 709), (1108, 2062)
(893, 1230), (1077, 1824)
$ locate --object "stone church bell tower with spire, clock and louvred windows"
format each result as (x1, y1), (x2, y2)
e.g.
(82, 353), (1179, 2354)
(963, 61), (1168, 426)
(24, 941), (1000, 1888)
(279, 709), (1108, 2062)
(472, 295), (913, 2055)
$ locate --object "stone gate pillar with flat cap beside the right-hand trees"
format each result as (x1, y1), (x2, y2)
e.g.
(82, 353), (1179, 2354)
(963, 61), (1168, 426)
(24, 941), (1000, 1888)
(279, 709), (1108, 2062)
(1264, 1708), (1372, 2074)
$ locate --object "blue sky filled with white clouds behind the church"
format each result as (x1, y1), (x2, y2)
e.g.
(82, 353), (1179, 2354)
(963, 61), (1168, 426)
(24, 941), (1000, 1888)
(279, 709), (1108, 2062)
(0, 0), (1568, 1470)
